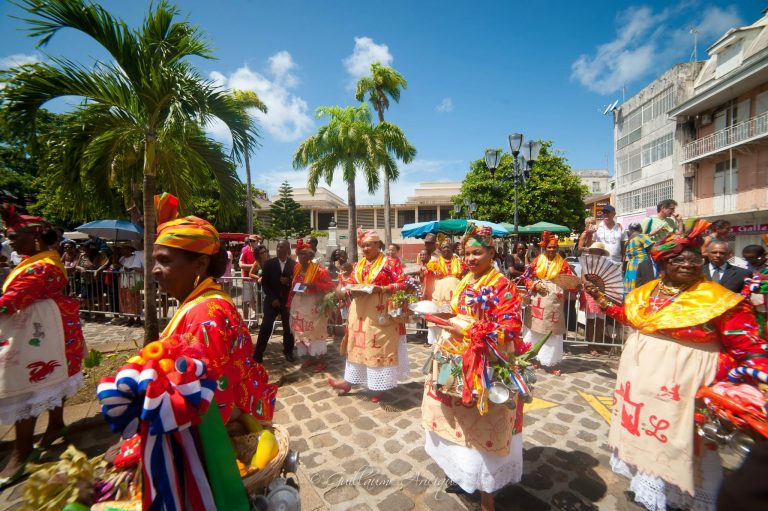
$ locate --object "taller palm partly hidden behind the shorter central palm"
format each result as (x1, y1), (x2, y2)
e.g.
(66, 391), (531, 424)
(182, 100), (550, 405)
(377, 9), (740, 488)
(355, 62), (408, 246)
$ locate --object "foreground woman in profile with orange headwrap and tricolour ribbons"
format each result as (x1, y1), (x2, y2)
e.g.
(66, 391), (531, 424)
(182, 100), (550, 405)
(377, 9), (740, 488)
(98, 194), (277, 511)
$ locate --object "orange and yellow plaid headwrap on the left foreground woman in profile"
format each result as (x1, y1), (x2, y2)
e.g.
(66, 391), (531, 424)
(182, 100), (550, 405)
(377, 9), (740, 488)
(155, 193), (221, 255)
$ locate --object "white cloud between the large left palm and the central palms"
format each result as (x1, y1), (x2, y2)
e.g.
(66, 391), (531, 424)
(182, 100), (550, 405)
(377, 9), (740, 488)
(206, 51), (314, 144)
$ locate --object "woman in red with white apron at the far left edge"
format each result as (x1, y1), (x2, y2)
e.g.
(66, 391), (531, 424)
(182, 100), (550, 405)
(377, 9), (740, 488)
(0, 205), (85, 487)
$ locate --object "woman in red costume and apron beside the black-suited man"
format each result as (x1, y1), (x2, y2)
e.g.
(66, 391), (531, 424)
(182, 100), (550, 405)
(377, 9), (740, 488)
(288, 239), (334, 373)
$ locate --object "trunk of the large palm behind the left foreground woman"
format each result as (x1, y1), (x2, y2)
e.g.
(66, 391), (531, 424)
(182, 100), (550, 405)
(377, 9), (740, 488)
(144, 134), (159, 345)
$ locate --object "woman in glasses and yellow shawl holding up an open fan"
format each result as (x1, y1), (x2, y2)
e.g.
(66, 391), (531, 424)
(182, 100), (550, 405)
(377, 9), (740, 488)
(585, 220), (768, 510)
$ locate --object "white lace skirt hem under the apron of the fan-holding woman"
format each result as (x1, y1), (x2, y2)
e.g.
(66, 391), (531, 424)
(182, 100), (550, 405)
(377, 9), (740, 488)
(611, 448), (723, 511)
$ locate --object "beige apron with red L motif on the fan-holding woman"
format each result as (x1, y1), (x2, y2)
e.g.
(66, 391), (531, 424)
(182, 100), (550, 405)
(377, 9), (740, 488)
(608, 331), (720, 495)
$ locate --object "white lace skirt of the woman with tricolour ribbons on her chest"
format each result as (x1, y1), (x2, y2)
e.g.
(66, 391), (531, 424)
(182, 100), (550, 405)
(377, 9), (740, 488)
(424, 431), (523, 493)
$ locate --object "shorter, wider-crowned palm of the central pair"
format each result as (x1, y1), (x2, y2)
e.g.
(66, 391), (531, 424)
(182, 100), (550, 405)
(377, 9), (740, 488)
(293, 103), (416, 261)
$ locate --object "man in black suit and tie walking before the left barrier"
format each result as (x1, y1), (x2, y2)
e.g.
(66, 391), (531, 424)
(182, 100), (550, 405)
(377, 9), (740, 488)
(253, 240), (296, 362)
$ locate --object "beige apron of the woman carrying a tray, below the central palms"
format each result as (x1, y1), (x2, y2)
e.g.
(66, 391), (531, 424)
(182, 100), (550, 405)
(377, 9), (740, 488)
(341, 293), (400, 367)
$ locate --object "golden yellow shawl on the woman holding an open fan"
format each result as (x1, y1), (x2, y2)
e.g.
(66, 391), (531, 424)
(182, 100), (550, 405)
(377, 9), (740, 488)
(624, 280), (744, 334)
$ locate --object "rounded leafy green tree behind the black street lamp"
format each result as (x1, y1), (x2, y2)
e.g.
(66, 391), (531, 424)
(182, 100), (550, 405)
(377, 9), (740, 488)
(453, 142), (587, 233)
